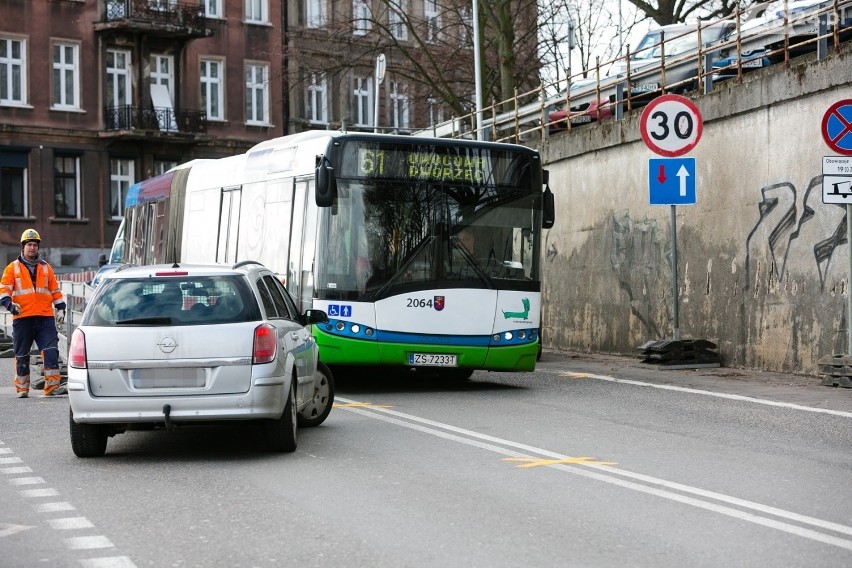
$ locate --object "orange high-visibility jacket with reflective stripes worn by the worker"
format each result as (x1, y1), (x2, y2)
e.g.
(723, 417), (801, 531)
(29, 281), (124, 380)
(0, 259), (65, 319)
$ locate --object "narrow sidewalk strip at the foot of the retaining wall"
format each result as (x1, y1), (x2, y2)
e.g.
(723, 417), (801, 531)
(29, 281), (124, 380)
(537, 349), (852, 414)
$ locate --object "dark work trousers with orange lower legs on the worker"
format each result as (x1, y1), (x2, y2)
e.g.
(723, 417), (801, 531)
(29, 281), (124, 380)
(12, 316), (61, 395)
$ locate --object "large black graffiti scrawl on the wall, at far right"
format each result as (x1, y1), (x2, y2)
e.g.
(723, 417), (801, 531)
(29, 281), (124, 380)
(744, 175), (848, 291)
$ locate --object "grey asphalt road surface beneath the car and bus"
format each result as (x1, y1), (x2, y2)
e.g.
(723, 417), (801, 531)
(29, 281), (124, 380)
(0, 353), (852, 568)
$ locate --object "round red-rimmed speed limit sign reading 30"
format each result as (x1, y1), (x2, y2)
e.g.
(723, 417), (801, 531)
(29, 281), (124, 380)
(639, 95), (704, 157)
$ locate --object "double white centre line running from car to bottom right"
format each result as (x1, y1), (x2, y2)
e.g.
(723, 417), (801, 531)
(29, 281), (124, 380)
(336, 396), (852, 550)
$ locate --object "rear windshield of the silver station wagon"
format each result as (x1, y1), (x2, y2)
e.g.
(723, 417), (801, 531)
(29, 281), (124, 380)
(82, 275), (260, 326)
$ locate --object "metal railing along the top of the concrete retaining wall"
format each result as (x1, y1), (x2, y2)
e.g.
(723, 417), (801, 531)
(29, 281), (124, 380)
(414, 0), (852, 143)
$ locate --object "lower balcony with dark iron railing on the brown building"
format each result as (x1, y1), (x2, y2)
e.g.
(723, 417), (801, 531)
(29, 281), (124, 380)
(104, 105), (207, 139)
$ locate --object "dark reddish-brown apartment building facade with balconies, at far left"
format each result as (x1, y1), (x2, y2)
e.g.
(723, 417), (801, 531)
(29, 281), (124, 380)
(0, 0), (283, 271)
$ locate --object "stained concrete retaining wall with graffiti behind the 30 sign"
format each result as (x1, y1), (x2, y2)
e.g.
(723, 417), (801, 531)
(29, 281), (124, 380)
(539, 42), (852, 374)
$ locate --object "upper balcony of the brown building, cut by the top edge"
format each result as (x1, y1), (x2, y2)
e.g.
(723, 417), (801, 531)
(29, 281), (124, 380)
(95, 0), (213, 39)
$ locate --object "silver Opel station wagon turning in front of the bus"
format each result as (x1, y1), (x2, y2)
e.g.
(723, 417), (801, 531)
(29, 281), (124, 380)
(68, 261), (334, 457)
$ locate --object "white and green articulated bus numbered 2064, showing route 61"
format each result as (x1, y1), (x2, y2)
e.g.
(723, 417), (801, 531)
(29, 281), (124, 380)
(113, 131), (554, 378)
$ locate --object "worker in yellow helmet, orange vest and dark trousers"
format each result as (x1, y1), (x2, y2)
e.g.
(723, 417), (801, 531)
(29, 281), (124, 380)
(0, 229), (68, 398)
